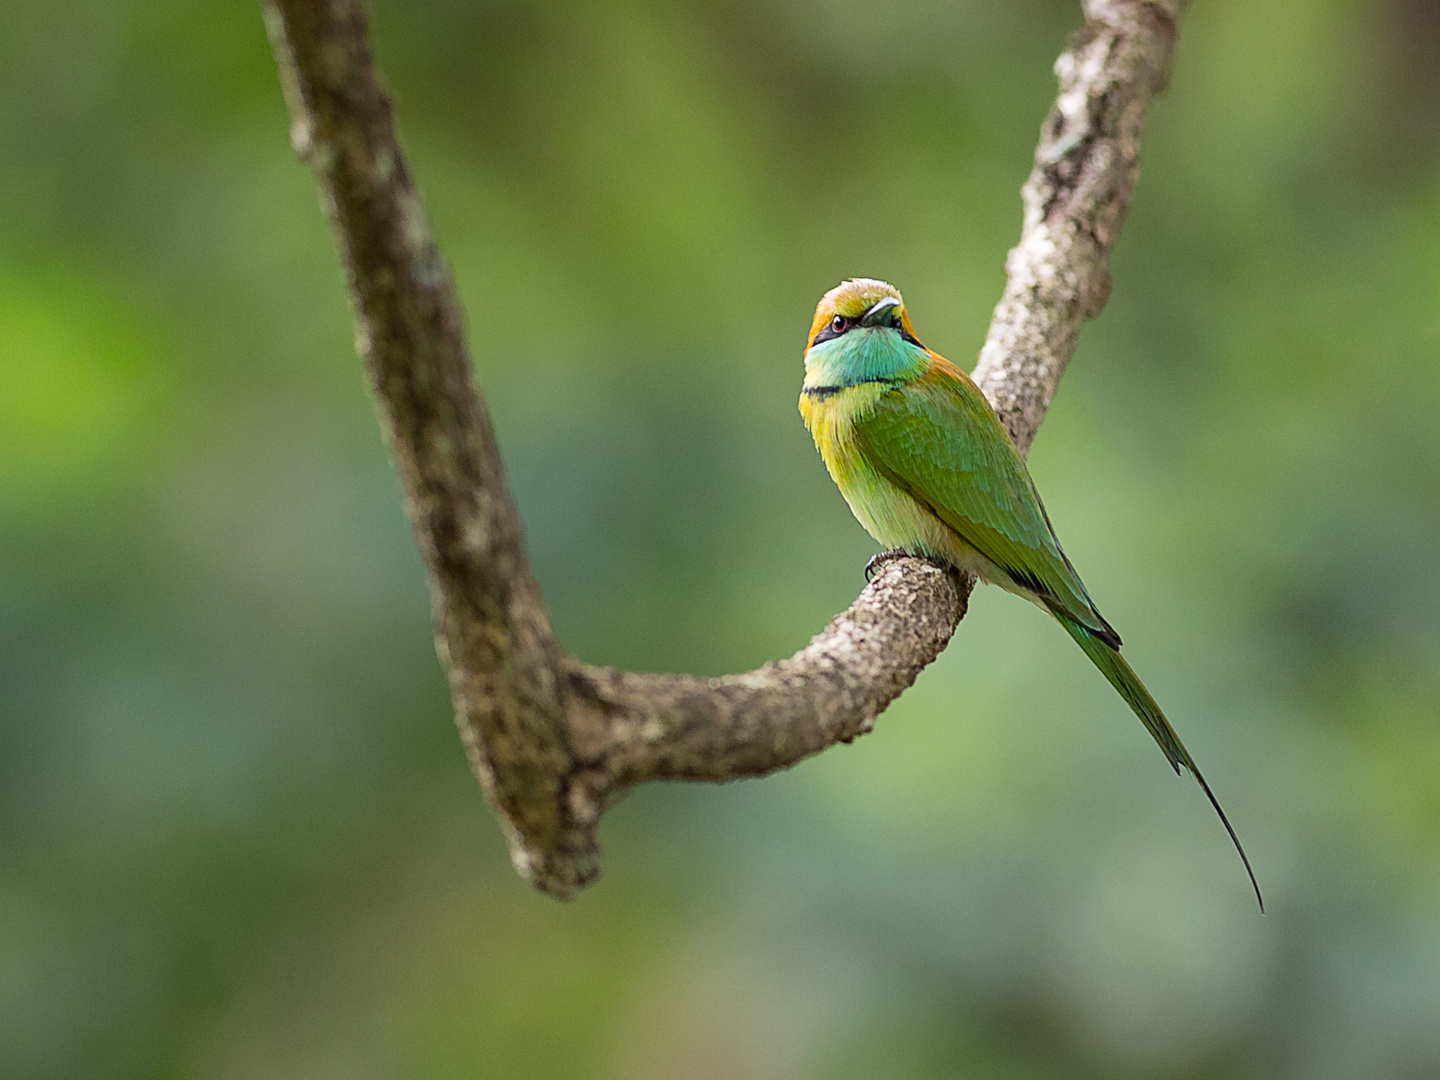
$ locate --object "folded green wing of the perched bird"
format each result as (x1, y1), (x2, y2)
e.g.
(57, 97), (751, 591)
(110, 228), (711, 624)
(855, 367), (1120, 648)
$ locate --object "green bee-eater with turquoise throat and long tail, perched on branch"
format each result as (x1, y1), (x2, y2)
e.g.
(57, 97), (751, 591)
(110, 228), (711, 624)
(799, 278), (1264, 913)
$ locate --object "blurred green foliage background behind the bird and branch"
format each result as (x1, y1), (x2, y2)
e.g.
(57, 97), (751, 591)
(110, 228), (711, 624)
(0, 0), (1440, 1080)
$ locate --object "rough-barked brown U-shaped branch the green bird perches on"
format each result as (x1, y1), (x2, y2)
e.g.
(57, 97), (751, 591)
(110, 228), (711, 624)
(262, 0), (1187, 897)
